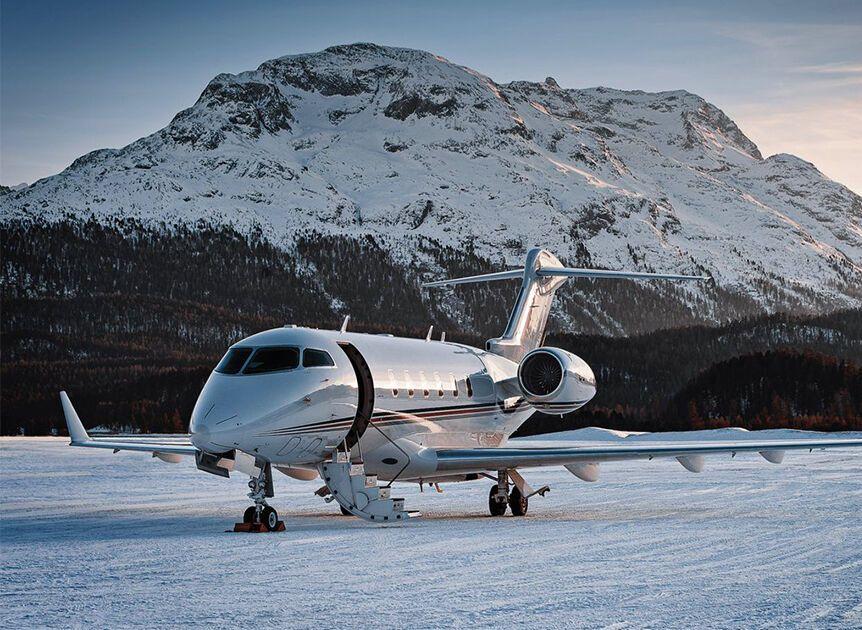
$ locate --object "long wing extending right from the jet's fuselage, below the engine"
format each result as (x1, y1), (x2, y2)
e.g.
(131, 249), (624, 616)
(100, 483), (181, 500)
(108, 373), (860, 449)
(435, 438), (862, 473)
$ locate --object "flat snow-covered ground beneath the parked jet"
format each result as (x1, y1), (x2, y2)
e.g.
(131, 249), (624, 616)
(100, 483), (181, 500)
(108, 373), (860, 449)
(0, 438), (862, 628)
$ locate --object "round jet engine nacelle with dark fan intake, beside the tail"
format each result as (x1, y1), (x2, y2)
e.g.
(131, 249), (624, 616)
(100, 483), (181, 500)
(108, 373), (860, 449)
(518, 347), (596, 415)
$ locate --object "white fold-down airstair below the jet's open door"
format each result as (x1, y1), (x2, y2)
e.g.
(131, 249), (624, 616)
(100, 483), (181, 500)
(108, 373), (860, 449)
(317, 452), (421, 523)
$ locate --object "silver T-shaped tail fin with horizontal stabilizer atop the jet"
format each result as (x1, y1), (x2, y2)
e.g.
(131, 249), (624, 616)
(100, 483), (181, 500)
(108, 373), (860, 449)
(422, 247), (709, 361)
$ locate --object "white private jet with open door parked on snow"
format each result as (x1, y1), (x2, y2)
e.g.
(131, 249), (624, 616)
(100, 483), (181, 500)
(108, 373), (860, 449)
(60, 248), (862, 530)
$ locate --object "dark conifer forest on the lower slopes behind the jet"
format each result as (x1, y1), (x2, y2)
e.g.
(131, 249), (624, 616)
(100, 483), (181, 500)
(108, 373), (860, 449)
(5, 222), (862, 434)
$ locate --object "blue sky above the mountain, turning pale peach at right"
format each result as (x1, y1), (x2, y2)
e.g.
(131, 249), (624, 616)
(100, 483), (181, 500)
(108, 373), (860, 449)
(0, 0), (862, 192)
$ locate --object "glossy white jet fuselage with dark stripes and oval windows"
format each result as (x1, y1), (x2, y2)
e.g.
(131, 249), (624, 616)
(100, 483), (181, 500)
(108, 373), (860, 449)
(189, 327), (595, 479)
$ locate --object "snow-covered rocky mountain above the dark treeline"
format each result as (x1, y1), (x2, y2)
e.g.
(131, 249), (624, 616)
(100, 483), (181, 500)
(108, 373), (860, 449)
(0, 44), (862, 333)
